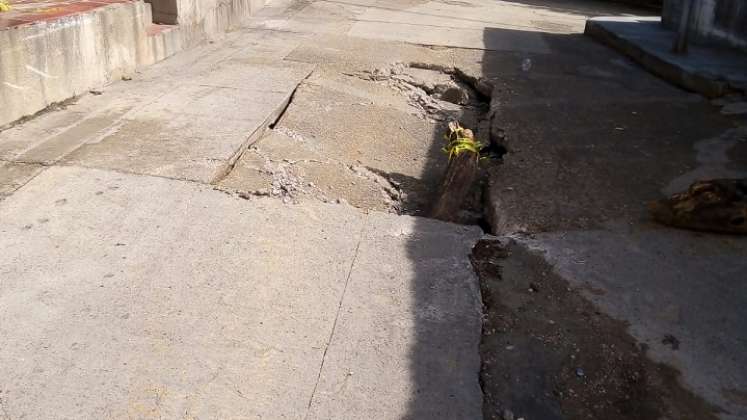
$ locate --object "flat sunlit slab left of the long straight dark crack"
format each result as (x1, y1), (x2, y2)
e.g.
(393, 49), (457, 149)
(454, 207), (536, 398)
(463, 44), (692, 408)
(59, 60), (313, 183)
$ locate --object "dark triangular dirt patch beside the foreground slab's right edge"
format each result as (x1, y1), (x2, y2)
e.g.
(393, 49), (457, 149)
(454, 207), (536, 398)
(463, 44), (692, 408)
(472, 240), (718, 420)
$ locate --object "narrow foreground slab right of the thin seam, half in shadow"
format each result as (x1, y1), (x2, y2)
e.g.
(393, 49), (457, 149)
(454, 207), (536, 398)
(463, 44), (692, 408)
(310, 214), (482, 419)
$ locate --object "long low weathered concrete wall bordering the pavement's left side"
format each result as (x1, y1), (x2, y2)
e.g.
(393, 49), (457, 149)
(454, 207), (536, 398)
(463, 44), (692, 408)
(0, 0), (266, 129)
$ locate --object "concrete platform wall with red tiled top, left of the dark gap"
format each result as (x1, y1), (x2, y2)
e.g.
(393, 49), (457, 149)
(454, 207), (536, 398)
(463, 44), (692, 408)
(0, 0), (178, 127)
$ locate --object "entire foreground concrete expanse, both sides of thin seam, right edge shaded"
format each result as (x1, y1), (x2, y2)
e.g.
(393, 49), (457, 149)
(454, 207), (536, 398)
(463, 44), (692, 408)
(0, 167), (481, 419)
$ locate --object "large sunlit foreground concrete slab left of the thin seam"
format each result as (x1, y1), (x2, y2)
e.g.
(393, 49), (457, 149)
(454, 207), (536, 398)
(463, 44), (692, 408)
(0, 168), (360, 419)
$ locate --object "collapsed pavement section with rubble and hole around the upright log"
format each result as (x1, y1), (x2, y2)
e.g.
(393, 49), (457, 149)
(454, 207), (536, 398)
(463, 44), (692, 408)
(218, 62), (501, 224)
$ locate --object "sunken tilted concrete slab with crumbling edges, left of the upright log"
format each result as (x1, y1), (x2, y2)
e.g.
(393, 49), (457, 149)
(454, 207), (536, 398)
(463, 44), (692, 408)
(219, 44), (494, 215)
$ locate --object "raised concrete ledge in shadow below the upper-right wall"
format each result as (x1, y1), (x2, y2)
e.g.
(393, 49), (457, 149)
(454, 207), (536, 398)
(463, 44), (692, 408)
(586, 17), (747, 98)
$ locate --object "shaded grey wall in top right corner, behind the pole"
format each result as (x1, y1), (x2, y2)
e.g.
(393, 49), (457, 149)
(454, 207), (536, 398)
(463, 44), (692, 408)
(662, 0), (747, 51)
